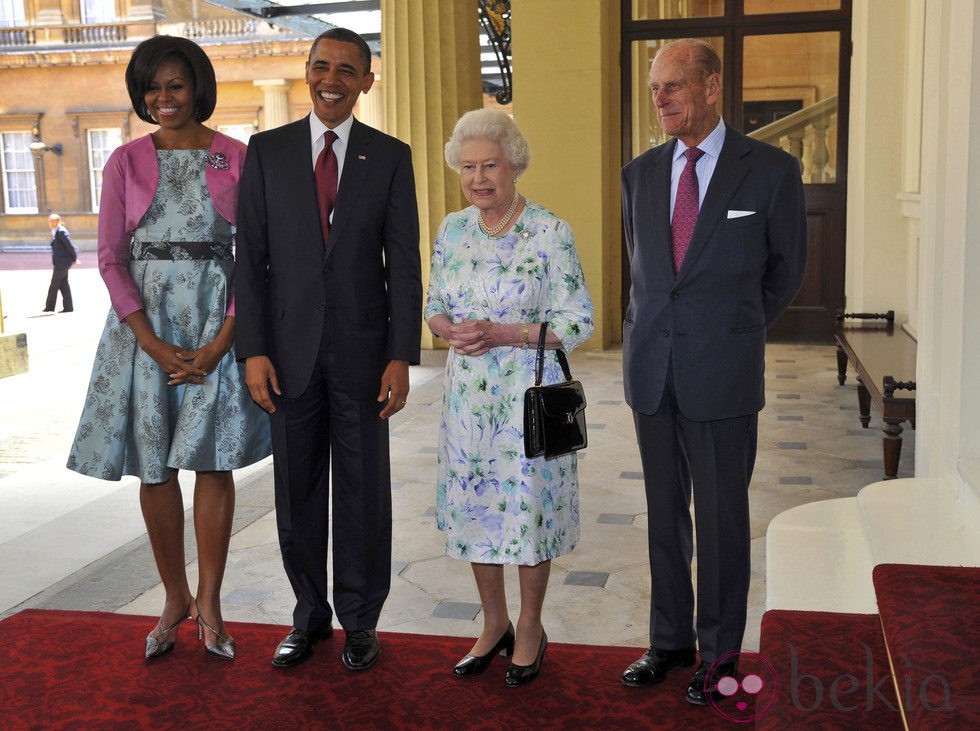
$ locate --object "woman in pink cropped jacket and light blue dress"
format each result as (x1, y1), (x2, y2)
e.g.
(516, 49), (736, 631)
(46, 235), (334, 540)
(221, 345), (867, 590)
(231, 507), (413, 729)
(68, 36), (271, 660)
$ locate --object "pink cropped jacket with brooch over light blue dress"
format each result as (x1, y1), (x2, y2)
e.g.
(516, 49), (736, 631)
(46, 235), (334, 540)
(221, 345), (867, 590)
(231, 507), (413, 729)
(99, 132), (245, 321)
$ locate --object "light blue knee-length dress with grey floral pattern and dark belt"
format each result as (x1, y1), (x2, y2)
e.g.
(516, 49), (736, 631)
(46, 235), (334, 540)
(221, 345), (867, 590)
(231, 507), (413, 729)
(68, 150), (271, 484)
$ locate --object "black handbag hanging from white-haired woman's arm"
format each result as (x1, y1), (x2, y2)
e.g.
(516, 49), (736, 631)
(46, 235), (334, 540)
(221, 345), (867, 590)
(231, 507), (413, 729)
(524, 322), (589, 459)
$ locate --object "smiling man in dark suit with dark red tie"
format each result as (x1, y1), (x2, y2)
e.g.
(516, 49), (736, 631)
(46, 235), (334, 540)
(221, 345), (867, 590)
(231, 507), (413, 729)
(235, 28), (422, 670)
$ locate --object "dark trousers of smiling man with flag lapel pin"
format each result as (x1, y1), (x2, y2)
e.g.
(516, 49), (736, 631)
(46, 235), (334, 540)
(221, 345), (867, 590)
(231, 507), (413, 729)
(271, 326), (391, 631)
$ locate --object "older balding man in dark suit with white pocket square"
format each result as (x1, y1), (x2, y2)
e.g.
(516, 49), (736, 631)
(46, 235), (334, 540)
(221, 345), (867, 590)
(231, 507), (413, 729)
(622, 39), (806, 705)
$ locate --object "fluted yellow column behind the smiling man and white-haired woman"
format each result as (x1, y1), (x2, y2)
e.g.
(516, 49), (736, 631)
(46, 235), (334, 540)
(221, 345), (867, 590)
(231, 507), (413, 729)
(381, 0), (483, 348)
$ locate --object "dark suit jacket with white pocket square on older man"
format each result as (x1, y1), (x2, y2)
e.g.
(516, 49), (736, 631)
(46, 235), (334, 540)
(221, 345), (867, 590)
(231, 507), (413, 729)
(622, 127), (807, 421)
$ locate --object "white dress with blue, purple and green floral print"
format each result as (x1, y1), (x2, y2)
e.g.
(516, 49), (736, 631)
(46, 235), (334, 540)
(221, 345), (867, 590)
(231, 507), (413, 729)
(425, 201), (594, 566)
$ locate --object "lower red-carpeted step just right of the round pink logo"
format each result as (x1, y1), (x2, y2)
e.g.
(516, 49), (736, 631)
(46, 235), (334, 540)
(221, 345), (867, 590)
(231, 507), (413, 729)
(756, 610), (902, 731)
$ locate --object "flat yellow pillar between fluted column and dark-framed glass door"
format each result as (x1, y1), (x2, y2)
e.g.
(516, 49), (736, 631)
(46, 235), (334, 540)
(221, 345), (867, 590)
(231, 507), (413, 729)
(511, 0), (623, 348)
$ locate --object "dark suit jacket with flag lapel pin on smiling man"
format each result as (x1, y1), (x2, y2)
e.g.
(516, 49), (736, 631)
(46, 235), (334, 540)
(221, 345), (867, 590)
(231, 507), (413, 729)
(235, 117), (422, 399)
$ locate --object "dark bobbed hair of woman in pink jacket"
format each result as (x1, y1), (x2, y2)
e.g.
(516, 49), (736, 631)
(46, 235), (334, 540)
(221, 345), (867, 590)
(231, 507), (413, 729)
(126, 36), (218, 124)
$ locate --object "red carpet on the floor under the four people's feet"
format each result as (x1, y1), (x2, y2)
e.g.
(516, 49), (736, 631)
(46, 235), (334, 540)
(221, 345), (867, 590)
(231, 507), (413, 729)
(0, 609), (745, 730)
